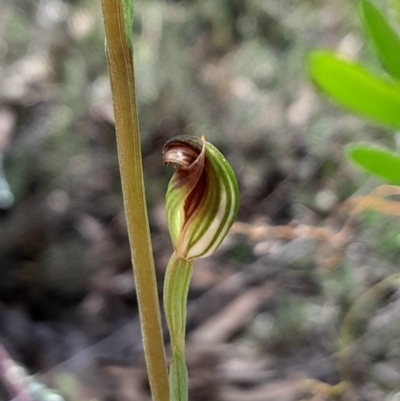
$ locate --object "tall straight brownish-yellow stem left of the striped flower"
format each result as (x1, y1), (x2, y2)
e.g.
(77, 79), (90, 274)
(102, 0), (169, 401)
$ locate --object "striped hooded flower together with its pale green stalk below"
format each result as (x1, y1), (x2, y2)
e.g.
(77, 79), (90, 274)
(163, 136), (239, 401)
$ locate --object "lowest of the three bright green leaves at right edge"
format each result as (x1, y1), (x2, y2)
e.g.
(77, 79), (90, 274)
(346, 145), (400, 185)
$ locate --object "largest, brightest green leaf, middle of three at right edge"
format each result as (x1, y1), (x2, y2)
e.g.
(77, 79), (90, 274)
(308, 51), (400, 129)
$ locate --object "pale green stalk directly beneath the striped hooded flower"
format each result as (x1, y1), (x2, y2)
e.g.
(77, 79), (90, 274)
(164, 252), (193, 401)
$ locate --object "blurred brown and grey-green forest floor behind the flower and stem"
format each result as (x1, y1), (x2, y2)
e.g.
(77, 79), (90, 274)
(0, 0), (400, 401)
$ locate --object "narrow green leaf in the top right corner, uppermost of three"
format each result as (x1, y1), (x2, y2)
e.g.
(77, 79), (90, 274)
(360, 0), (400, 80)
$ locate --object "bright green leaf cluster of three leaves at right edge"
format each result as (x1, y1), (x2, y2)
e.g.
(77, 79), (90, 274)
(308, 0), (400, 185)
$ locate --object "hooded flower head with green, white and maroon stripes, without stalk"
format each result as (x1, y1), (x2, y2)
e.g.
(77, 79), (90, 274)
(163, 136), (239, 260)
